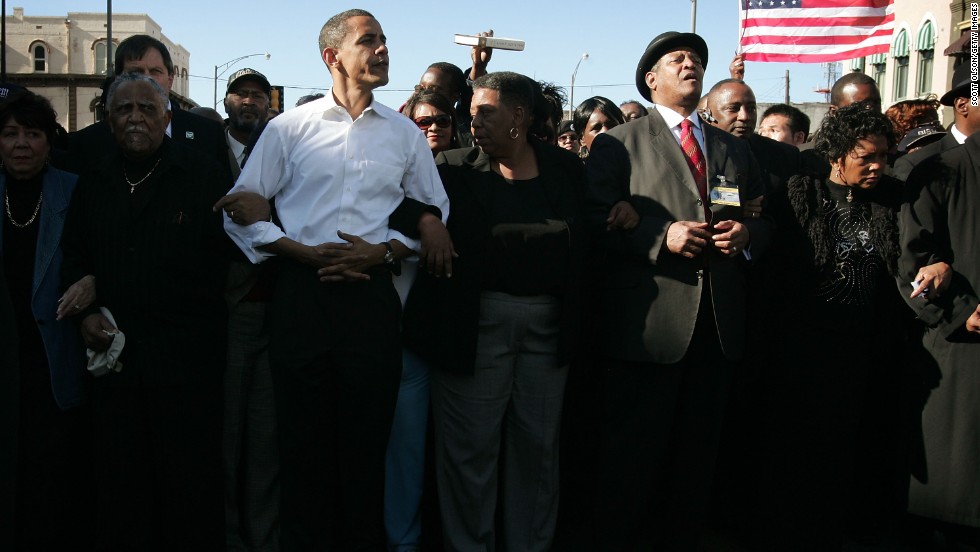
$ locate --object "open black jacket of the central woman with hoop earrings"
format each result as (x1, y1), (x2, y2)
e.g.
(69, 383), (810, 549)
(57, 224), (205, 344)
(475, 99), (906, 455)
(403, 139), (585, 373)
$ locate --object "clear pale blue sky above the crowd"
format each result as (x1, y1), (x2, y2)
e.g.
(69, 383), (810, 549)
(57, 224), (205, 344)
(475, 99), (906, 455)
(40, 0), (846, 111)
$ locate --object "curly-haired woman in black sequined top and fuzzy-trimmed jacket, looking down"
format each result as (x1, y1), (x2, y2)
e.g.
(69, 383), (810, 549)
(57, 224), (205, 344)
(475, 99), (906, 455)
(747, 104), (913, 551)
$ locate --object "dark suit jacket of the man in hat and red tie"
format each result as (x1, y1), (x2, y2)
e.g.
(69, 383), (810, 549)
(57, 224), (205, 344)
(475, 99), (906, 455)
(586, 110), (769, 364)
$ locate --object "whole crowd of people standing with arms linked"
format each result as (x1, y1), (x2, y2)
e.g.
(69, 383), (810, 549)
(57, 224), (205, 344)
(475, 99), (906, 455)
(0, 10), (980, 552)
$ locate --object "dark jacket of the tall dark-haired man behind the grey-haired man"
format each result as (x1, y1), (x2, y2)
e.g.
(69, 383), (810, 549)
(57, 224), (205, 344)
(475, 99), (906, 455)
(54, 102), (232, 182)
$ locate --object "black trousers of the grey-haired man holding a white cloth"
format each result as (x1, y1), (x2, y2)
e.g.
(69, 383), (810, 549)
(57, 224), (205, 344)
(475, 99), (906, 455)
(92, 374), (224, 552)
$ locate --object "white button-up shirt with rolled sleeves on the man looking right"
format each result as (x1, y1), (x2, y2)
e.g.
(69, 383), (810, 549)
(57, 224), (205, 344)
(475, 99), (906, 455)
(225, 90), (449, 263)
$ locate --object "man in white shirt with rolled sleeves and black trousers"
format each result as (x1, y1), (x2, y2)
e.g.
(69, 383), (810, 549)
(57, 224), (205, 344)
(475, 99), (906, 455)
(225, 10), (448, 551)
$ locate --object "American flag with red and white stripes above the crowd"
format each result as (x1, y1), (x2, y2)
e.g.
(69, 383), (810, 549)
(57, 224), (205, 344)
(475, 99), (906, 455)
(739, 0), (895, 63)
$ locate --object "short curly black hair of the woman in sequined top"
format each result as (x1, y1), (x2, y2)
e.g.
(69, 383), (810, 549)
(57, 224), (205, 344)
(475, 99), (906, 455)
(813, 102), (895, 162)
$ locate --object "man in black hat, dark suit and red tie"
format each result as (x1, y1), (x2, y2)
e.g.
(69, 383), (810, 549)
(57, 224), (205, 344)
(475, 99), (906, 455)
(586, 32), (768, 550)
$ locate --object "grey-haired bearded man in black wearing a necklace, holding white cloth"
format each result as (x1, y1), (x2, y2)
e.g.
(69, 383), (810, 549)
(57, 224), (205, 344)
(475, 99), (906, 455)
(61, 73), (232, 551)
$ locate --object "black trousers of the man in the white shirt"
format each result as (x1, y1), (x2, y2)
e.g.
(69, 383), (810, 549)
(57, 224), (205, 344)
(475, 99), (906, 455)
(269, 263), (401, 552)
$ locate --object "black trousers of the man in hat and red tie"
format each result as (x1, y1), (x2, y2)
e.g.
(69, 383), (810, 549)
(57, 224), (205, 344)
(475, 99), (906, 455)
(594, 291), (732, 551)
